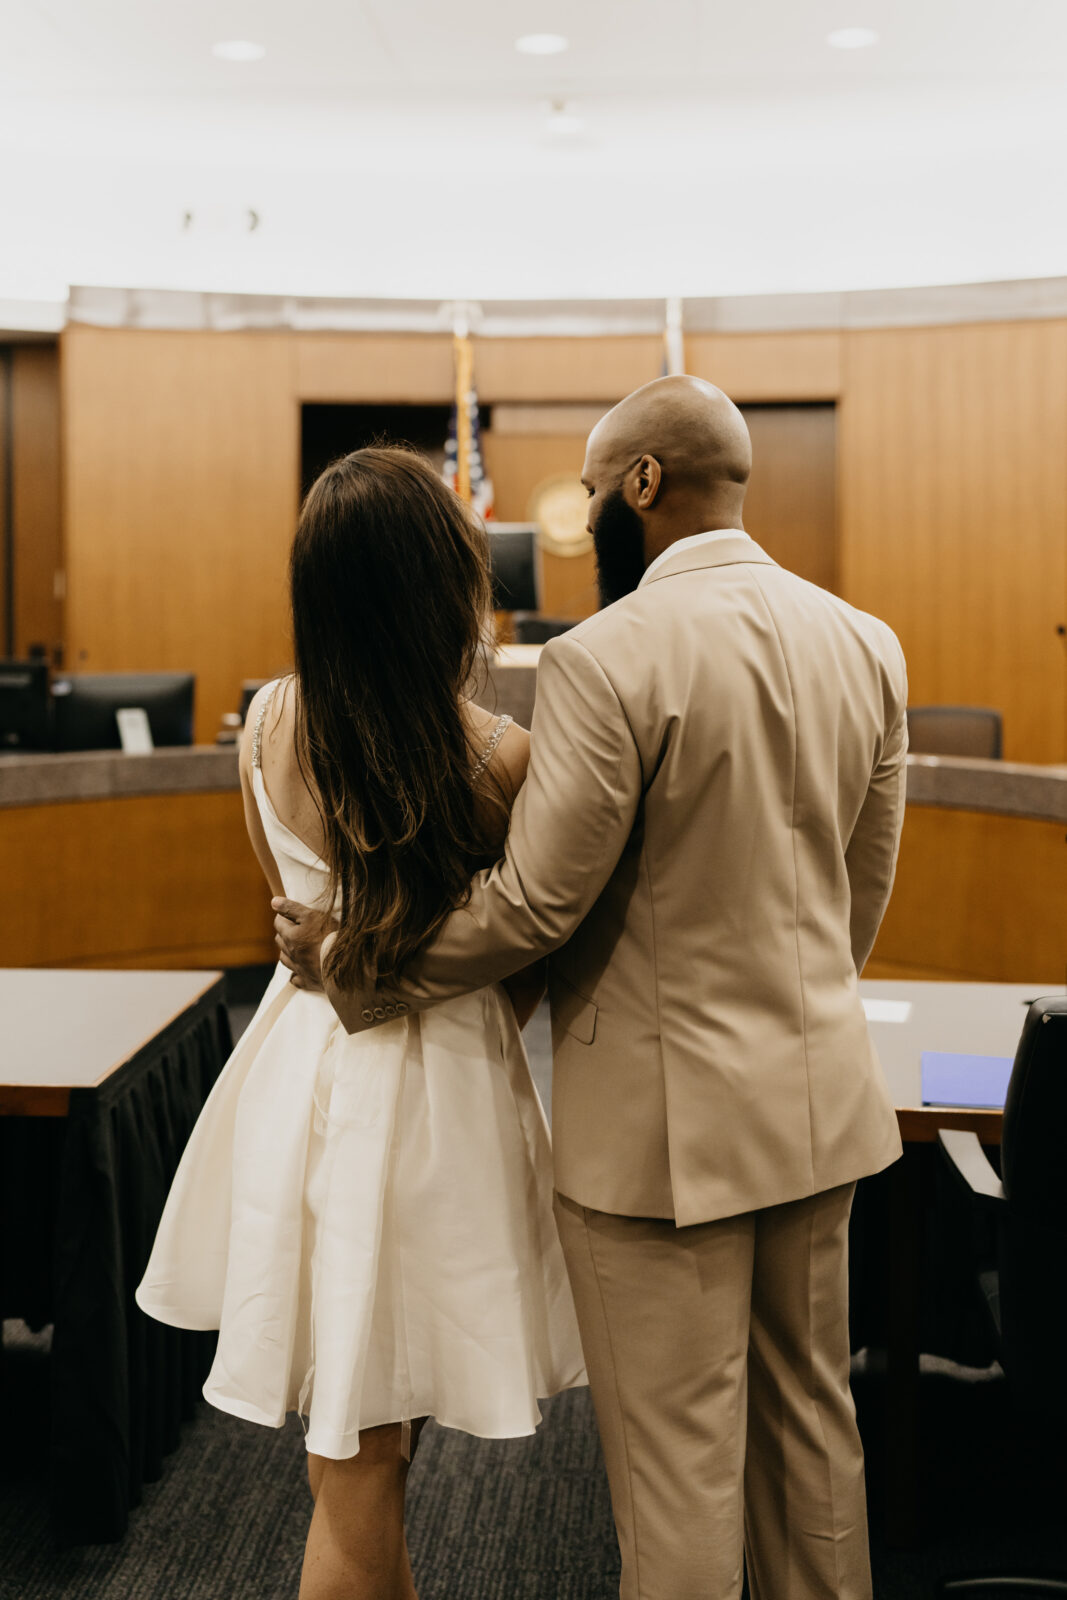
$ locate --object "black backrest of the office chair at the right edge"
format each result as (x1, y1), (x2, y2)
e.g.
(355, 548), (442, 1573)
(1000, 995), (1067, 1421)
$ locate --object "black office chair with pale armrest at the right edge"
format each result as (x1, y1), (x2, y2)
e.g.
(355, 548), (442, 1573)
(937, 995), (1067, 1595)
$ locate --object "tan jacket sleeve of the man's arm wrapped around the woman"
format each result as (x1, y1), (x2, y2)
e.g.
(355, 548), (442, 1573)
(326, 635), (643, 1034)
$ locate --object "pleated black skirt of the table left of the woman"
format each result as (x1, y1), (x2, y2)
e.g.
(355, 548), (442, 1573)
(0, 981), (230, 1544)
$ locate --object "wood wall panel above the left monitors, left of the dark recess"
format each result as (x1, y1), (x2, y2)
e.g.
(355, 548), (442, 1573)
(62, 328), (299, 742)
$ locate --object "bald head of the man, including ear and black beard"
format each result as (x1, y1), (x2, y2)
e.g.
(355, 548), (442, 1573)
(582, 378), (752, 605)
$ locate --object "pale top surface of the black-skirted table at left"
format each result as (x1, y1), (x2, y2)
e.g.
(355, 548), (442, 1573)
(0, 968), (222, 1110)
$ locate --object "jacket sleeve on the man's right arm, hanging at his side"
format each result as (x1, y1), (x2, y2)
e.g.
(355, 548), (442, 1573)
(845, 640), (907, 973)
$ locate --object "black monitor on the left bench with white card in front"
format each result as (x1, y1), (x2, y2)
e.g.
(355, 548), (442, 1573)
(51, 672), (197, 750)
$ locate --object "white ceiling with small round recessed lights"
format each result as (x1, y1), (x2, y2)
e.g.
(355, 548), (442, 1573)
(0, 0), (1067, 308)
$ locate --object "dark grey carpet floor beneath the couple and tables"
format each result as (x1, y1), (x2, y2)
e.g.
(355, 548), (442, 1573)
(0, 979), (1067, 1600)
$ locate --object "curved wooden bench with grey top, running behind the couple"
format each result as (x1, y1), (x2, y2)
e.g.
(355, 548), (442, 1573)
(0, 645), (1067, 987)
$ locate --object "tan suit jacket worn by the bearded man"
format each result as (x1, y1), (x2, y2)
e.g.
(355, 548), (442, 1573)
(333, 534), (907, 1226)
